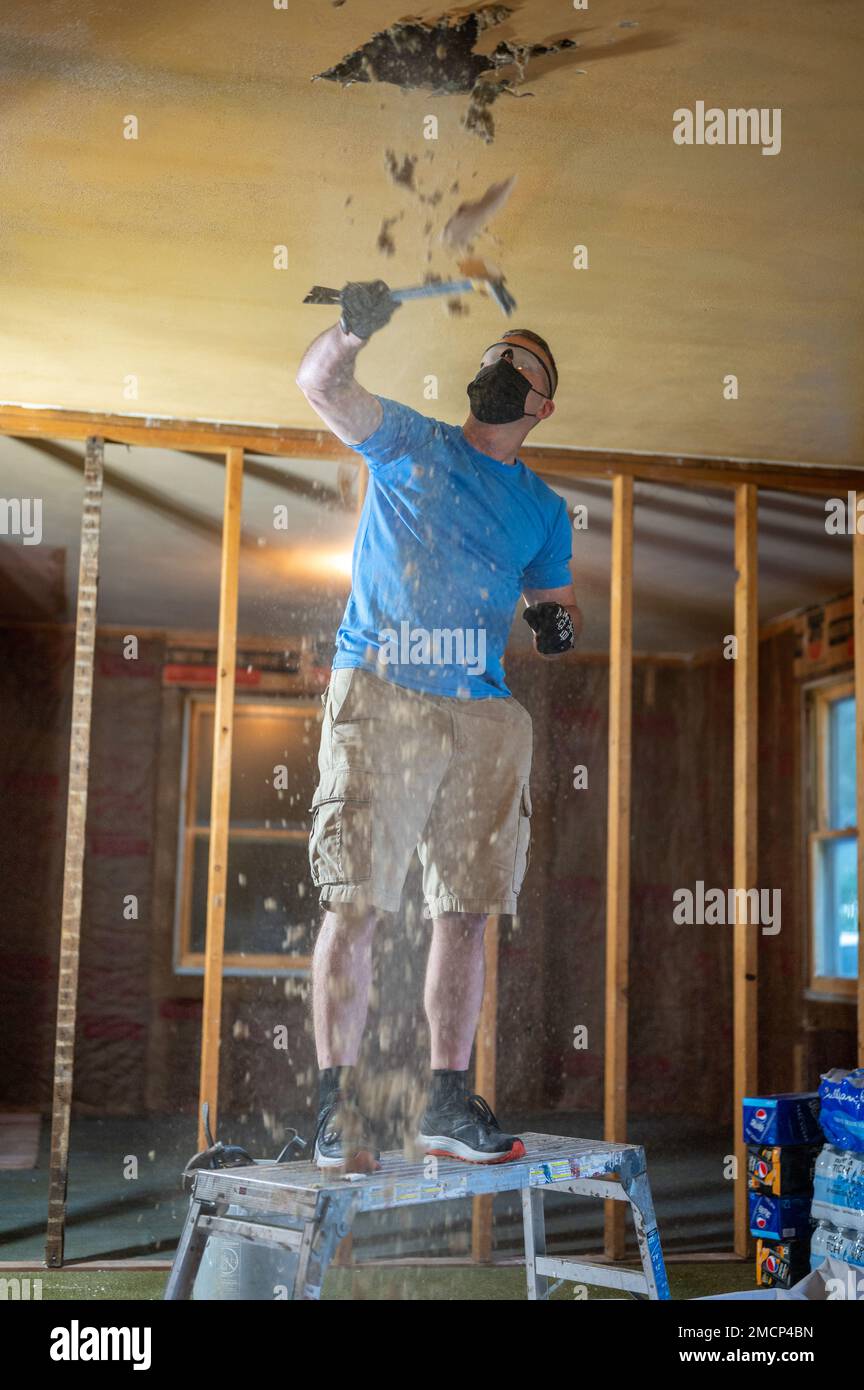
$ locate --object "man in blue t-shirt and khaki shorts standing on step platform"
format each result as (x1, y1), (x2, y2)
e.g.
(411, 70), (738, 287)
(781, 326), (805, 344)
(297, 281), (582, 1172)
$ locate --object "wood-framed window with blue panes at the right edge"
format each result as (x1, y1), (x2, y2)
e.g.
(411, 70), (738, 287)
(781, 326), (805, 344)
(808, 678), (858, 995)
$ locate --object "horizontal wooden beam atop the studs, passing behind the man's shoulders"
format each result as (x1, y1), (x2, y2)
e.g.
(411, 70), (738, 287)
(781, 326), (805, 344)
(0, 403), (863, 496)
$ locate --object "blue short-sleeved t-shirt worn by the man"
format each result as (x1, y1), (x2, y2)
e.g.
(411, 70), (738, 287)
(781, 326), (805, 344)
(333, 396), (572, 699)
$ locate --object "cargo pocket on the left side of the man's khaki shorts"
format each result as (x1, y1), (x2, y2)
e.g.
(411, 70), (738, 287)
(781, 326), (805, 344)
(308, 769), (372, 888)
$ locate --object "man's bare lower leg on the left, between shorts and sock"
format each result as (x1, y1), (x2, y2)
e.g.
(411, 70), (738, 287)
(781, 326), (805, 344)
(313, 904), (378, 1070)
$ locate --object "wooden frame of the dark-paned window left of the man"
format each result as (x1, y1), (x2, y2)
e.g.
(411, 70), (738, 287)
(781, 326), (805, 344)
(174, 689), (321, 980)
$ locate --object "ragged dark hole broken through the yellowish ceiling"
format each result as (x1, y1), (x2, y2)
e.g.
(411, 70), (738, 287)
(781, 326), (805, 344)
(313, 4), (576, 142)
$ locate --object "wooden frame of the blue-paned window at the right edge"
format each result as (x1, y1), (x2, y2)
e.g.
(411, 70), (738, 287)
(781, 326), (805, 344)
(803, 670), (861, 1004)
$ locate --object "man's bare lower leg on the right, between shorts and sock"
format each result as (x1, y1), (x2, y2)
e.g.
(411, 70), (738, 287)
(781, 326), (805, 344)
(424, 912), (486, 1072)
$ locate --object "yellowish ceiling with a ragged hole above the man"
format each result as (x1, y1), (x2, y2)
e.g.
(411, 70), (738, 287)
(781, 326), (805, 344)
(0, 0), (864, 464)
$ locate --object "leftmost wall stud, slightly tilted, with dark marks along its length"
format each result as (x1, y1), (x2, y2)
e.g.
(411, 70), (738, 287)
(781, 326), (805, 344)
(44, 438), (104, 1269)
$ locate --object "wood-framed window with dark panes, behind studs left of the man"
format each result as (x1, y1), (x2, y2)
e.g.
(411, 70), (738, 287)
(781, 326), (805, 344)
(175, 694), (321, 974)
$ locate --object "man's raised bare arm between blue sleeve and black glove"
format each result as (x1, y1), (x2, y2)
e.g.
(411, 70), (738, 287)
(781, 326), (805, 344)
(297, 324), (383, 443)
